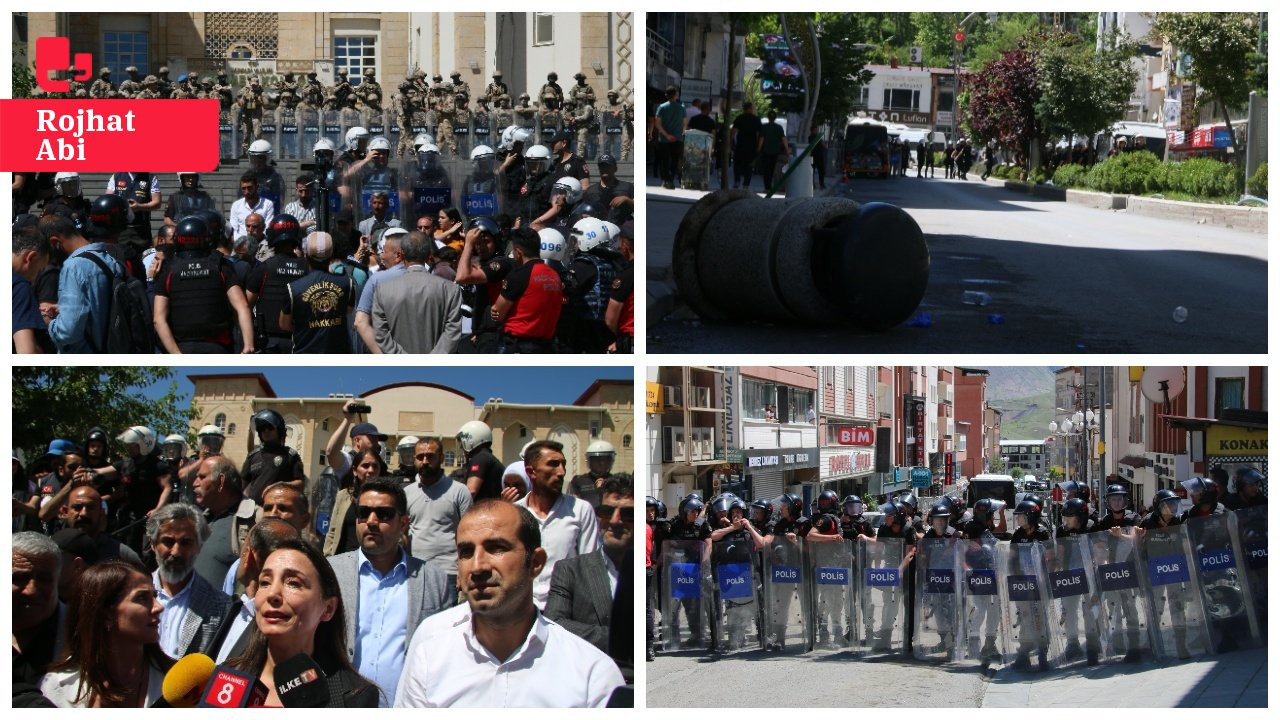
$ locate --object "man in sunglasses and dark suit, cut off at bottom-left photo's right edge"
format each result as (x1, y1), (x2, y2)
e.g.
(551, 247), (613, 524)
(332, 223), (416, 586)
(547, 478), (635, 676)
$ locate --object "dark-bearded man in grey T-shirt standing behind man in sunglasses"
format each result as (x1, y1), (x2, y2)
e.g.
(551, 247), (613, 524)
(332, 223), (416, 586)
(404, 437), (471, 588)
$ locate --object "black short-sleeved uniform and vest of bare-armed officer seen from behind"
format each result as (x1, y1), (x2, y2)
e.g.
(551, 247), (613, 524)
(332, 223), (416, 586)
(155, 252), (239, 354)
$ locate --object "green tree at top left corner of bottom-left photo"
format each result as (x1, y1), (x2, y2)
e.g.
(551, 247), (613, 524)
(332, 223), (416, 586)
(13, 366), (197, 459)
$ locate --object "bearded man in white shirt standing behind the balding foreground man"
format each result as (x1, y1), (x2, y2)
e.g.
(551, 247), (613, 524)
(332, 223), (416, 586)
(516, 439), (600, 610)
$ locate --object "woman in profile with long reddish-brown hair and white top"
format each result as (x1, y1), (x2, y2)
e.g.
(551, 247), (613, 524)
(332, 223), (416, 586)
(40, 560), (173, 707)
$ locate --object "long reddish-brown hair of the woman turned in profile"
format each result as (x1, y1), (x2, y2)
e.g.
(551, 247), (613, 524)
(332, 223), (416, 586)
(49, 560), (173, 705)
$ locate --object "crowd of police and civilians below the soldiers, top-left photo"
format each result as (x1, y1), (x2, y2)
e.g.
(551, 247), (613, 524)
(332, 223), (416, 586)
(13, 127), (635, 354)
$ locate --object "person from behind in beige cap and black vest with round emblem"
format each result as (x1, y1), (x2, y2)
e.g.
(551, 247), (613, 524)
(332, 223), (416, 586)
(280, 232), (356, 355)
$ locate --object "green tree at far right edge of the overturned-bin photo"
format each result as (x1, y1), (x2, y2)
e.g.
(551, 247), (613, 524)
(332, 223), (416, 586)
(1151, 13), (1260, 156)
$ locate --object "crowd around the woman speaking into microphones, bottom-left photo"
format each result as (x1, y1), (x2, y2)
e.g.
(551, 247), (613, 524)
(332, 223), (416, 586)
(13, 401), (634, 707)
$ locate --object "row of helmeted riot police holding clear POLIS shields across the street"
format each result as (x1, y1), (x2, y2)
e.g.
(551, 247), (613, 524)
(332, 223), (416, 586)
(648, 469), (1267, 676)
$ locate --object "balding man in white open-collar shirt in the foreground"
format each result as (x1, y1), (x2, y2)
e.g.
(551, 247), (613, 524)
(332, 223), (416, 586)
(396, 498), (623, 707)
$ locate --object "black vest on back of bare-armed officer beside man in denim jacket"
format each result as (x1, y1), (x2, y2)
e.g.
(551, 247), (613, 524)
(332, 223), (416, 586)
(165, 254), (234, 342)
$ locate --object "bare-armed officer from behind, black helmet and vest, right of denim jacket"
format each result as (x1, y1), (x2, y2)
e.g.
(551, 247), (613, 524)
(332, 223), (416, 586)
(155, 215), (253, 355)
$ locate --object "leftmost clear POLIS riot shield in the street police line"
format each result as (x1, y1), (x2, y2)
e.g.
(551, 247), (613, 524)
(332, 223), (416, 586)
(659, 539), (708, 651)
